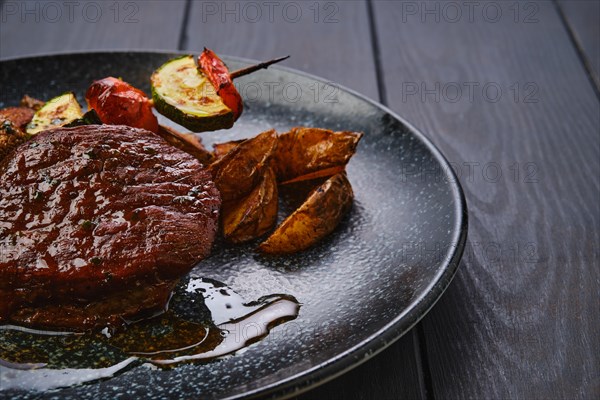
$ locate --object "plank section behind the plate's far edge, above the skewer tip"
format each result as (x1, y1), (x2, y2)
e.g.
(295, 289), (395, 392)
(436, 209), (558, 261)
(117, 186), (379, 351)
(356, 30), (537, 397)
(185, 0), (378, 99)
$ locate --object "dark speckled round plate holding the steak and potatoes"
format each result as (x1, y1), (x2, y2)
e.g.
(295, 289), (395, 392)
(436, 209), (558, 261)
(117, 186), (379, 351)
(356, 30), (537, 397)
(0, 53), (467, 399)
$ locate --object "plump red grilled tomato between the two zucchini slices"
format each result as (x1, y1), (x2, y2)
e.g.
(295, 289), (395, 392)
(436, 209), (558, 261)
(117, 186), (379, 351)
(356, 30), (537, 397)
(85, 77), (158, 133)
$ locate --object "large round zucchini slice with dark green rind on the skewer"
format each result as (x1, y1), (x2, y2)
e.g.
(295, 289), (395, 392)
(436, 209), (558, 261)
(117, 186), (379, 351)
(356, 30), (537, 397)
(151, 55), (234, 132)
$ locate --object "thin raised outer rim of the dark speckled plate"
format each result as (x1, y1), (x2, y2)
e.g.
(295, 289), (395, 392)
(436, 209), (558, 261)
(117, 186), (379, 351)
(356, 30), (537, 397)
(0, 49), (468, 400)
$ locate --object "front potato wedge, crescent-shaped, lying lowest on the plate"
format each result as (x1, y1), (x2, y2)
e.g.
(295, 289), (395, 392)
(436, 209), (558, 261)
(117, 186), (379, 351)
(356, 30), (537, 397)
(258, 172), (354, 254)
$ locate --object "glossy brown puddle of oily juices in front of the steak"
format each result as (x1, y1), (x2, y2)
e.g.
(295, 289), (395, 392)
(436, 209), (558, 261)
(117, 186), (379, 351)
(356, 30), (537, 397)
(0, 276), (300, 392)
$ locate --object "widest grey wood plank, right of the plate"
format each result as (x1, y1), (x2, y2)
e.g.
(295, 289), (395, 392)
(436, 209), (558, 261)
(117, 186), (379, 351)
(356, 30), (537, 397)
(373, 1), (600, 399)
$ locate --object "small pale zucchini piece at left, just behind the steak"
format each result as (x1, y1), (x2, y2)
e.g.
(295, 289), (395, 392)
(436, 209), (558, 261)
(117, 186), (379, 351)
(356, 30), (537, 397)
(27, 92), (83, 135)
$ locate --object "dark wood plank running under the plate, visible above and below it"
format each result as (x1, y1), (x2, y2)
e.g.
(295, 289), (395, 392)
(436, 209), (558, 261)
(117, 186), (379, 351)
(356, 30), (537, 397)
(185, 1), (423, 400)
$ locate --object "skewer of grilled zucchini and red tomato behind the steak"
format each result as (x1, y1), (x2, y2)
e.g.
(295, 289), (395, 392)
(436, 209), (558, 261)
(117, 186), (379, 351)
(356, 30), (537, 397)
(21, 48), (289, 137)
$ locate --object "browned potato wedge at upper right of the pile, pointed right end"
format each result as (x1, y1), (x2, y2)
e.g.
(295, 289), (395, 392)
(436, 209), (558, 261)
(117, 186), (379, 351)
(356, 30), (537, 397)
(273, 127), (362, 182)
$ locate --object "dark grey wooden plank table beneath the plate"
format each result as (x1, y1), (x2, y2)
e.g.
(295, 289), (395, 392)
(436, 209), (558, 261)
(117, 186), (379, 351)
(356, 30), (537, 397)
(0, 0), (600, 400)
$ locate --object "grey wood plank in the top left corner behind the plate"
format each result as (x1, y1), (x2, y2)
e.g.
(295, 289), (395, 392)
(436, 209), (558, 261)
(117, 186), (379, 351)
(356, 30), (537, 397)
(0, 0), (185, 58)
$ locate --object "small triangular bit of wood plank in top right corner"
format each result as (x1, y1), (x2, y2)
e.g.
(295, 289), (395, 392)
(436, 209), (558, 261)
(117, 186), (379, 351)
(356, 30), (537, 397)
(558, 0), (600, 87)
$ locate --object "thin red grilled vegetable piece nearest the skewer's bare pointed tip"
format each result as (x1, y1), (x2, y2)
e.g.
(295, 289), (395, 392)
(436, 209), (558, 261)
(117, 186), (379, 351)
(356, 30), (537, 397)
(198, 48), (244, 120)
